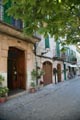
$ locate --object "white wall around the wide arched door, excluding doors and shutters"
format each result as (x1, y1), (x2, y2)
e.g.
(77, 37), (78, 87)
(37, 36), (64, 83)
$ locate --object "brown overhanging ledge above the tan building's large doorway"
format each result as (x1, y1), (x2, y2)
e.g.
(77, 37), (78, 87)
(0, 21), (40, 44)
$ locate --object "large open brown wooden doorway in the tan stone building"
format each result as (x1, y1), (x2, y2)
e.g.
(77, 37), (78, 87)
(7, 47), (26, 94)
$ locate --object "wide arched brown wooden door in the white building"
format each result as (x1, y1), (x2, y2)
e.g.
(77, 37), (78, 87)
(43, 61), (52, 85)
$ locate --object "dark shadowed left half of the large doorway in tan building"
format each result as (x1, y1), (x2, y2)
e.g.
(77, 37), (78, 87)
(8, 47), (18, 90)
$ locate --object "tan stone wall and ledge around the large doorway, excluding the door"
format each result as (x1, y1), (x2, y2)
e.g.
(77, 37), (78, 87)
(0, 22), (38, 92)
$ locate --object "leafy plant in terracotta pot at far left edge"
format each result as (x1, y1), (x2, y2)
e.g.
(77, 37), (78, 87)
(0, 75), (8, 103)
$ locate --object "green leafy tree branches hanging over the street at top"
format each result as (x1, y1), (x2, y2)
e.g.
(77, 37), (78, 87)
(3, 0), (80, 44)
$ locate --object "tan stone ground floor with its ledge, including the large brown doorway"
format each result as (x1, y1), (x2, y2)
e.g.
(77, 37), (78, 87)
(0, 21), (39, 95)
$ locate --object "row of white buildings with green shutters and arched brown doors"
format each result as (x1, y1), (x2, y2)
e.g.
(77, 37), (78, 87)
(36, 36), (80, 85)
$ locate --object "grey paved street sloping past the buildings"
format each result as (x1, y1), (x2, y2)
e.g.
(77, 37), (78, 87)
(0, 77), (80, 120)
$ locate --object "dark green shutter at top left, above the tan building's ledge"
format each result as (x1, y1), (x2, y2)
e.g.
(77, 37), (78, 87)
(3, 0), (11, 24)
